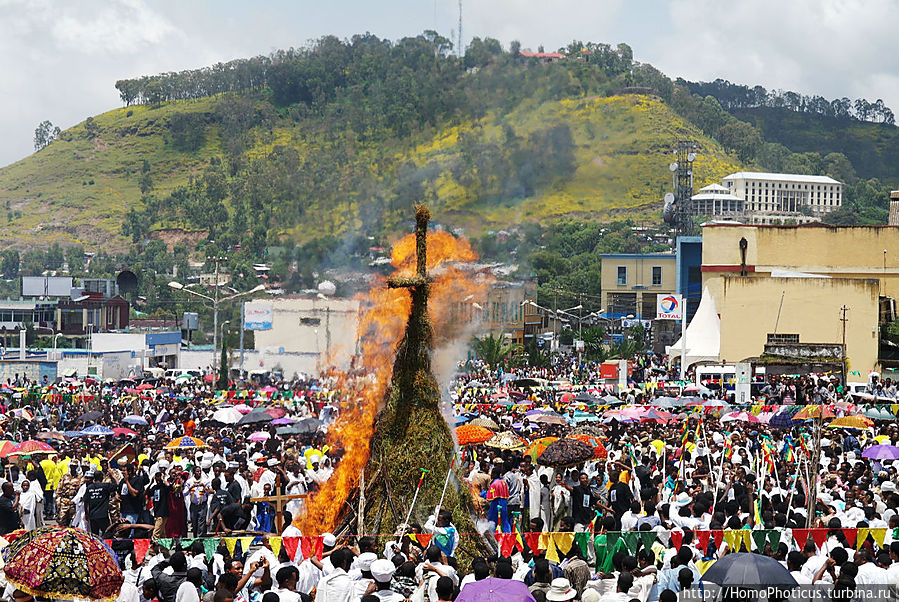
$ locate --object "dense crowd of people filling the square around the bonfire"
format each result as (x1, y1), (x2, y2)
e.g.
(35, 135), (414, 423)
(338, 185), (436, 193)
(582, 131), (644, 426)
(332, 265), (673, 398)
(0, 356), (899, 602)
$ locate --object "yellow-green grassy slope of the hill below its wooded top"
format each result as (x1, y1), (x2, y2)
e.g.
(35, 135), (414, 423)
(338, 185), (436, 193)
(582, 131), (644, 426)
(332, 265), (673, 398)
(0, 90), (740, 251)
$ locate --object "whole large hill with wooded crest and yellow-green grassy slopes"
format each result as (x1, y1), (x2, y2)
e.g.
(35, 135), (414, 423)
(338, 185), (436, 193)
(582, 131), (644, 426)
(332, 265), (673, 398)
(0, 33), (751, 251)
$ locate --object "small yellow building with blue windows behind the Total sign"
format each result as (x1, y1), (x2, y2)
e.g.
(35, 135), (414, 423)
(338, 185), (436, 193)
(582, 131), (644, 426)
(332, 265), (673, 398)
(601, 253), (677, 320)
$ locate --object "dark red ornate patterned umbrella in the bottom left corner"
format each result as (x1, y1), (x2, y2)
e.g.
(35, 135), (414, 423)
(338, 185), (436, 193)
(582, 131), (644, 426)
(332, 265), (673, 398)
(3, 527), (124, 600)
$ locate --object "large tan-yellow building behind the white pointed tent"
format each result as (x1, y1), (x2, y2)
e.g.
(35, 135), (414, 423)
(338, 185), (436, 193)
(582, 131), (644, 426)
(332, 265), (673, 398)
(702, 223), (899, 380)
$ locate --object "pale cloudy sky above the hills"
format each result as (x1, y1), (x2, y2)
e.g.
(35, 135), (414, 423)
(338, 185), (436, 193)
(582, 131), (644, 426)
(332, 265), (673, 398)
(0, 0), (899, 165)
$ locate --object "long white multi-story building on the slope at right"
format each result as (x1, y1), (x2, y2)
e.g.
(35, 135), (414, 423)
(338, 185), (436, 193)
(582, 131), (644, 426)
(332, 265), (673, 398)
(693, 171), (843, 224)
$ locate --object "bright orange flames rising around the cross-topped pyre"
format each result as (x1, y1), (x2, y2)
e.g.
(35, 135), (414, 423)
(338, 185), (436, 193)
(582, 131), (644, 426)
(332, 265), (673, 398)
(295, 232), (486, 535)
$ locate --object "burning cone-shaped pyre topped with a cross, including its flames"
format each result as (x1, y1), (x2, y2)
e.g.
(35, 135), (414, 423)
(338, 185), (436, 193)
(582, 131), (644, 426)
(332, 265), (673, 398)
(296, 206), (486, 546)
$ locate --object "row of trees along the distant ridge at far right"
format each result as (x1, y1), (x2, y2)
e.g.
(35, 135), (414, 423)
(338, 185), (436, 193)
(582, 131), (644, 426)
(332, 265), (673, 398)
(677, 78), (896, 125)
